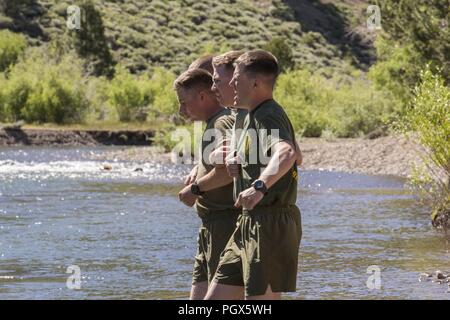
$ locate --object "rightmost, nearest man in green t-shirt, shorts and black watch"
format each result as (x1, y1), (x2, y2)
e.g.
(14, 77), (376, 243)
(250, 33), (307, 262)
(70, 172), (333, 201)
(206, 50), (301, 299)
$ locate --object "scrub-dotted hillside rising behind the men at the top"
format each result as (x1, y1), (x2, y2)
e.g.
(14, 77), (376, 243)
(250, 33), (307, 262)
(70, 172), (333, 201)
(0, 0), (374, 74)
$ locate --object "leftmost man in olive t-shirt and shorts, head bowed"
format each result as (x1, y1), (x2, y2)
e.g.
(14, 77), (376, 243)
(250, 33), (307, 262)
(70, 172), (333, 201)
(174, 69), (240, 299)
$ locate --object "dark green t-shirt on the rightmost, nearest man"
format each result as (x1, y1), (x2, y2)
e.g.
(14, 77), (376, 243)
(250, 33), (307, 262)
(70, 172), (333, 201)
(234, 100), (298, 207)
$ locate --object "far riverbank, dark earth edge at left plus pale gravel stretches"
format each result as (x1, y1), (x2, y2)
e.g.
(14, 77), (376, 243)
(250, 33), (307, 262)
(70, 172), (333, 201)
(0, 127), (432, 177)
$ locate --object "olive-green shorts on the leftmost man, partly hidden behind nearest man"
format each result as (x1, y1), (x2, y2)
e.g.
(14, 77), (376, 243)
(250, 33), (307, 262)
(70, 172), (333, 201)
(192, 210), (240, 284)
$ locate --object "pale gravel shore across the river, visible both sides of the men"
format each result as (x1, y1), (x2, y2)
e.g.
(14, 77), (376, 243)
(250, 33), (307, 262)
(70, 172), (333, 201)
(89, 136), (423, 177)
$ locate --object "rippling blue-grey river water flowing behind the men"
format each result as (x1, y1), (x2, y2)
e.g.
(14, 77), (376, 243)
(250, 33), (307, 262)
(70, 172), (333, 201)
(0, 147), (450, 299)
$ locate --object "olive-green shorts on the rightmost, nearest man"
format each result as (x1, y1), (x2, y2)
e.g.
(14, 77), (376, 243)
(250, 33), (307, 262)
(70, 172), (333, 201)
(213, 206), (302, 296)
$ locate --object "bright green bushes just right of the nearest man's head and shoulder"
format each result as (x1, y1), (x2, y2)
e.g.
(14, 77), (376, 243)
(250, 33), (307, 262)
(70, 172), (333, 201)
(275, 70), (395, 137)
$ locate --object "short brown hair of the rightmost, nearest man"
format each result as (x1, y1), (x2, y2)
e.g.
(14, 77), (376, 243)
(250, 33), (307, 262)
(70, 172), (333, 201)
(235, 50), (280, 81)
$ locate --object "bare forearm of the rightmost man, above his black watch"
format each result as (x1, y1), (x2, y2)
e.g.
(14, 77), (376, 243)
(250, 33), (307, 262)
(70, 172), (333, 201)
(259, 142), (297, 188)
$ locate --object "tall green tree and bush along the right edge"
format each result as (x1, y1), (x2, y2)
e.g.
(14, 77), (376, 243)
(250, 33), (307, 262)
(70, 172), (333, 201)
(369, 0), (450, 226)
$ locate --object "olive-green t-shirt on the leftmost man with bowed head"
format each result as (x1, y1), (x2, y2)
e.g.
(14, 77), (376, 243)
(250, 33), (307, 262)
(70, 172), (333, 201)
(196, 109), (235, 213)
